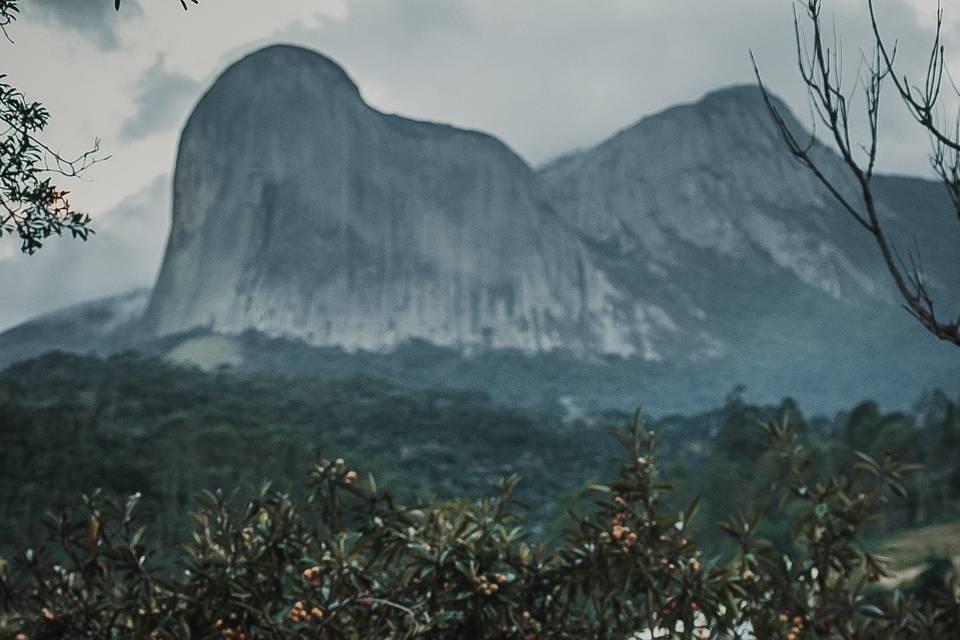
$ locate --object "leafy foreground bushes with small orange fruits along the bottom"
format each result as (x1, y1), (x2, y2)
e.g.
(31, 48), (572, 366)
(0, 418), (960, 640)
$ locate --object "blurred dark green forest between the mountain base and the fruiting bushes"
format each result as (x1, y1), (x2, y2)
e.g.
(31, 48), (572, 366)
(0, 353), (960, 551)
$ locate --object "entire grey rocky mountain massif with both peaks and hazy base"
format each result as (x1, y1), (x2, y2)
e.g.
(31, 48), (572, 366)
(0, 46), (960, 411)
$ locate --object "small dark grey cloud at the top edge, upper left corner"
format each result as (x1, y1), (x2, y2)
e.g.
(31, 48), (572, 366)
(25, 0), (143, 49)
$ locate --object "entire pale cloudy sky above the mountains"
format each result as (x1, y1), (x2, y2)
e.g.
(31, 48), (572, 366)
(0, 0), (960, 330)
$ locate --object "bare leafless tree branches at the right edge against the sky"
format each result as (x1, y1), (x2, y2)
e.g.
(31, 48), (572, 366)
(751, 0), (960, 347)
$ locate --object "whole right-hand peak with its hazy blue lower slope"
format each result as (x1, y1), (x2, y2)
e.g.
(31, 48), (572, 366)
(538, 87), (960, 389)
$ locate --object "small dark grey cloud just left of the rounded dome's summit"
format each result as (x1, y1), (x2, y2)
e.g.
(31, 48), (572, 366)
(120, 53), (200, 142)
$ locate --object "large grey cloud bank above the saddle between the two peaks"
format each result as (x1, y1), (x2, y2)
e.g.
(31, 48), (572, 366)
(253, 0), (931, 171)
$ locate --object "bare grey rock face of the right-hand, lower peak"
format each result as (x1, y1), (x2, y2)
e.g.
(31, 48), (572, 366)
(540, 87), (878, 299)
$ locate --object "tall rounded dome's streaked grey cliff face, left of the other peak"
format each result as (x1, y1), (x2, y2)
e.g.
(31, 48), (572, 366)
(145, 46), (712, 358)
